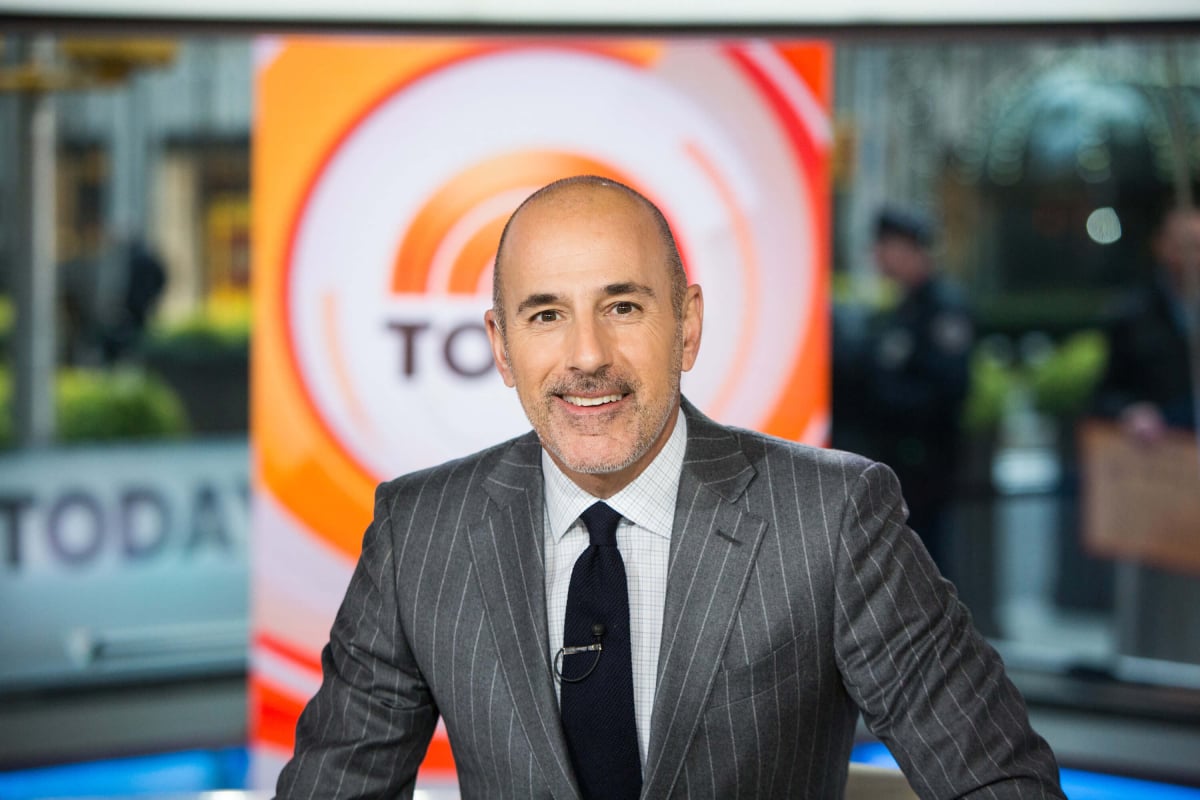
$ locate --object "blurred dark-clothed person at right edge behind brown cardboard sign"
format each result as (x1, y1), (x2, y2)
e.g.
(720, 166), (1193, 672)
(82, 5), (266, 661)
(1096, 200), (1200, 444)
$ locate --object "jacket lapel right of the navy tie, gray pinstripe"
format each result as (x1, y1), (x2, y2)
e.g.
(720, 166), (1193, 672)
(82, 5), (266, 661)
(642, 401), (767, 799)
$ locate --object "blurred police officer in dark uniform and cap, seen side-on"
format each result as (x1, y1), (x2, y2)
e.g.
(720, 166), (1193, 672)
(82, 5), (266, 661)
(833, 207), (974, 575)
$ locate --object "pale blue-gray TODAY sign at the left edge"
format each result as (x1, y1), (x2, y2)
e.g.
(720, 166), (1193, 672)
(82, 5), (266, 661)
(0, 439), (250, 690)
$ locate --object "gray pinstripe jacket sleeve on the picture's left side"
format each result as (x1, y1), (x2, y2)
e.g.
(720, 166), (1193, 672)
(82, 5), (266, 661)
(276, 488), (438, 800)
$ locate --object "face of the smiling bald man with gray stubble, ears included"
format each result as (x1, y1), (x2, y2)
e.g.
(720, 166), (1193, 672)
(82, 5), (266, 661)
(485, 186), (703, 497)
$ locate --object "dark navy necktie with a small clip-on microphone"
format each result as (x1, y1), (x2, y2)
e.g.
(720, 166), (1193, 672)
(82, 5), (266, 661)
(560, 503), (642, 800)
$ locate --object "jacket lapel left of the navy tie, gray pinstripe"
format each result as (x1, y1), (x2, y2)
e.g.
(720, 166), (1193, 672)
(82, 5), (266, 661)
(469, 434), (578, 798)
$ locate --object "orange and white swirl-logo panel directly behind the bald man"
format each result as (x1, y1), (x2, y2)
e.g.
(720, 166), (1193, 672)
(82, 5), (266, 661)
(251, 37), (832, 786)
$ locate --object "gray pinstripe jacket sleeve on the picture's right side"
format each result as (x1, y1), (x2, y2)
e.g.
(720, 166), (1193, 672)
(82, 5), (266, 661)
(834, 464), (1063, 799)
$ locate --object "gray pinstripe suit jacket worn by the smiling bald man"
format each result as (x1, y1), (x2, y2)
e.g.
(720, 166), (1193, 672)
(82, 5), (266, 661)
(277, 401), (1062, 800)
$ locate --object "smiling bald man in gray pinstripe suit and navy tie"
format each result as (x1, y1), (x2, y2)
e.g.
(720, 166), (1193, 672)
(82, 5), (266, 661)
(278, 178), (1061, 799)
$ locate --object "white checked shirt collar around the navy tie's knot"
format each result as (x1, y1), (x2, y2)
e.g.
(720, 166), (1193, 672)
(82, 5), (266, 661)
(541, 408), (688, 540)
